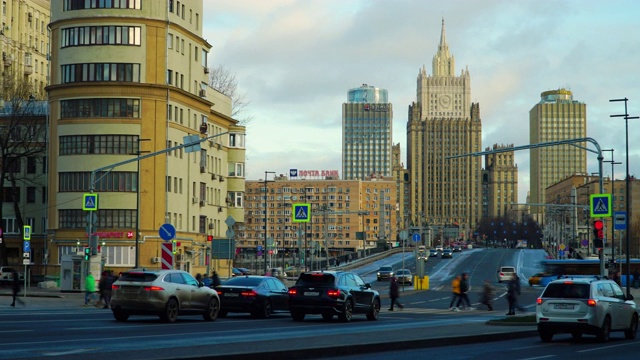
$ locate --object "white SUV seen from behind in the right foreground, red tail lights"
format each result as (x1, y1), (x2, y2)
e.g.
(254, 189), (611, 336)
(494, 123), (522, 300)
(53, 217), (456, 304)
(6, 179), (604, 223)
(536, 276), (638, 342)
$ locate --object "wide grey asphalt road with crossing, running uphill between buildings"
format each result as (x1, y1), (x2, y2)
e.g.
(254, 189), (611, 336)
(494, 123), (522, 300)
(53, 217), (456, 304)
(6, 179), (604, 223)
(0, 249), (635, 360)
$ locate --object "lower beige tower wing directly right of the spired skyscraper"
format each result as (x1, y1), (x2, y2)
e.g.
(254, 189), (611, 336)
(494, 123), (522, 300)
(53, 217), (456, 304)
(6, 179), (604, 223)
(482, 144), (518, 218)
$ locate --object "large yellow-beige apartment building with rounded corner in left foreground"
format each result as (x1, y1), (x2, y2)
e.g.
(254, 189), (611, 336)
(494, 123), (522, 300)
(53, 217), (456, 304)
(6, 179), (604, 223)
(48, 0), (245, 284)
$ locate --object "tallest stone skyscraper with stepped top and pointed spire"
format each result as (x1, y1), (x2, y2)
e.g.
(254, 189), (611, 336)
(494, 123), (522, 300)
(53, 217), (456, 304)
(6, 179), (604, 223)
(407, 19), (482, 238)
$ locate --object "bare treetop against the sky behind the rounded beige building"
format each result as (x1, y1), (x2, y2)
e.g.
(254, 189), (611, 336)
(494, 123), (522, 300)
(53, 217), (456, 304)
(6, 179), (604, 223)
(209, 65), (253, 126)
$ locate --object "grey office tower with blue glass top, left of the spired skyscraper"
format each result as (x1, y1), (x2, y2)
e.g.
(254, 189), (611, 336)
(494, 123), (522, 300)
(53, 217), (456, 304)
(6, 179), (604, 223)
(342, 84), (393, 180)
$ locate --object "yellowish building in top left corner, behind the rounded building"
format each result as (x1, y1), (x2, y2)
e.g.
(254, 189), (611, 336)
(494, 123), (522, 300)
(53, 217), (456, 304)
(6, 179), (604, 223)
(0, 0), (51, 100)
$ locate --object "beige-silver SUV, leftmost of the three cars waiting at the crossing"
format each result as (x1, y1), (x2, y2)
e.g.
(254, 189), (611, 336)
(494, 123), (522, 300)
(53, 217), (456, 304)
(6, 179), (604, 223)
(111, 269), (220, 323)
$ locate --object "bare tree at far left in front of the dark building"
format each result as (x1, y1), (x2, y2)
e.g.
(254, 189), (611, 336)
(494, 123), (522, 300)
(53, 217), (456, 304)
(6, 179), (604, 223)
(0, 81), (48, 265)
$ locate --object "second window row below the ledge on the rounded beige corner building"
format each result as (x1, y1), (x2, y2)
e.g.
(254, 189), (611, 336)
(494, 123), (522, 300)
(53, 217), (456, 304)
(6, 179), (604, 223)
(59, 135), (140, 155)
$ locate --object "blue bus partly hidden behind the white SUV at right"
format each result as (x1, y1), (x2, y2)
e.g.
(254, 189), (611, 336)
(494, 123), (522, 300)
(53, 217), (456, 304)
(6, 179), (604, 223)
(540, 259), (640, 287)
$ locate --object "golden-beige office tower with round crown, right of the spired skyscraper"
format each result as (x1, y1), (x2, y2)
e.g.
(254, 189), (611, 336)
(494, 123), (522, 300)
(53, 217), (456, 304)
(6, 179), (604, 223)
(529, 89), (587, 217)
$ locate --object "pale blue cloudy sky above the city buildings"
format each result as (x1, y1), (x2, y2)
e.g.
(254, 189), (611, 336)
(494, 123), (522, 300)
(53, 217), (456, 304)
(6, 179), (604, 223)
(203, 0), (640, 202)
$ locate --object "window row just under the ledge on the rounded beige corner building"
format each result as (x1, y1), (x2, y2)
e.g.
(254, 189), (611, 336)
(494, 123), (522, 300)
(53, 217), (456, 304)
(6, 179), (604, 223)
(60, 98), (140, 119)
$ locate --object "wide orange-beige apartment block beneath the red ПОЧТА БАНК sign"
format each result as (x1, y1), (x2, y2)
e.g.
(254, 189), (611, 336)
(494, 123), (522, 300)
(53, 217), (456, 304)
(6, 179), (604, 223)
(236, 175), (398, 258)
